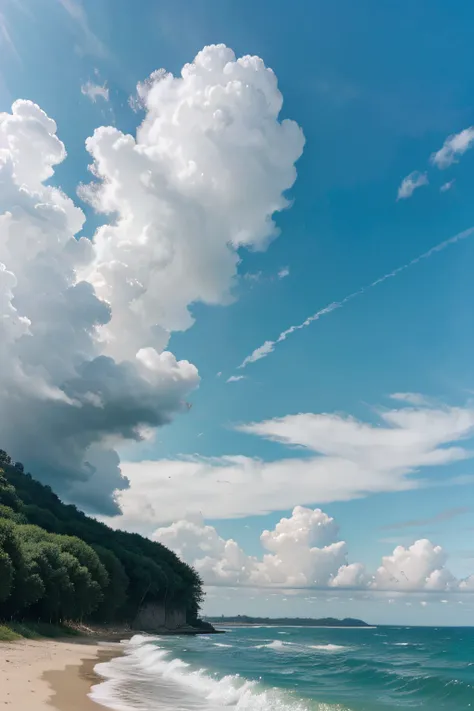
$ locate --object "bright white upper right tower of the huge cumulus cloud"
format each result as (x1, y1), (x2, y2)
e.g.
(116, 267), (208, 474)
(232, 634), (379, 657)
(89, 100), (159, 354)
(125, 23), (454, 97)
(81, 45), (304, 357)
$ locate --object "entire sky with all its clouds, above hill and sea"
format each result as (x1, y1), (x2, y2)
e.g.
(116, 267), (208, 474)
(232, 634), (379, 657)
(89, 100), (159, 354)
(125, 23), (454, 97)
(0, 0), (474, 625)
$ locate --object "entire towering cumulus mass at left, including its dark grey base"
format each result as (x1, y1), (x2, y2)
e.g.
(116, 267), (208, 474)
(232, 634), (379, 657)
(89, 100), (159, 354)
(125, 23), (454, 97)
(0, 46), (303, 513)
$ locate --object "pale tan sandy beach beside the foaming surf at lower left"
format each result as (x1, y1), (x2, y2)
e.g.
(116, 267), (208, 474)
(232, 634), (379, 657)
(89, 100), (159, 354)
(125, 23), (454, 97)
(0, 639), (120, 711)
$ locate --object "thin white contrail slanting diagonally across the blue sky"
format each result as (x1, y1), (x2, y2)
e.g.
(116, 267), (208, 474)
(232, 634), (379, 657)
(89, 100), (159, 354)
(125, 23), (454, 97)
(239, 227), (474, 368)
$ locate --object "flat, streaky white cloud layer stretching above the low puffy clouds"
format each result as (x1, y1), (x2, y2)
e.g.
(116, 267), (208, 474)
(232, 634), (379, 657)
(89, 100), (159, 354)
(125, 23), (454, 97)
(112, 398), (474, 532)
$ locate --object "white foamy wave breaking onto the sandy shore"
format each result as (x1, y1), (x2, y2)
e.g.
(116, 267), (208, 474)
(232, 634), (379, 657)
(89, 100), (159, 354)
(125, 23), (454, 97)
(90, 635), (344, 711)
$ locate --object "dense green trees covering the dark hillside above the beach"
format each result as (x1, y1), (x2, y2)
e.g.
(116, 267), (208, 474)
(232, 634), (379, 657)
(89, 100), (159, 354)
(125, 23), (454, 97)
(0, 450), (203, 624)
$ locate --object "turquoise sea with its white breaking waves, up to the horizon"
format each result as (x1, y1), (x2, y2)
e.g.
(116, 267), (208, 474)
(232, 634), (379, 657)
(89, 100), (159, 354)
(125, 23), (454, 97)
(90, 627), (474, 711)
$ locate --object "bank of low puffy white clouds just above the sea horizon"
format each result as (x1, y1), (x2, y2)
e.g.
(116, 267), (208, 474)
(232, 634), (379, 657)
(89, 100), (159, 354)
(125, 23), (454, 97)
(152, 506), (474, 605)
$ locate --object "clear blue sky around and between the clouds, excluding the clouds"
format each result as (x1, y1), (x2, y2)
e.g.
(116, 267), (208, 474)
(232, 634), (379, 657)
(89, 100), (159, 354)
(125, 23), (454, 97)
(0, 0), (474, 624)
